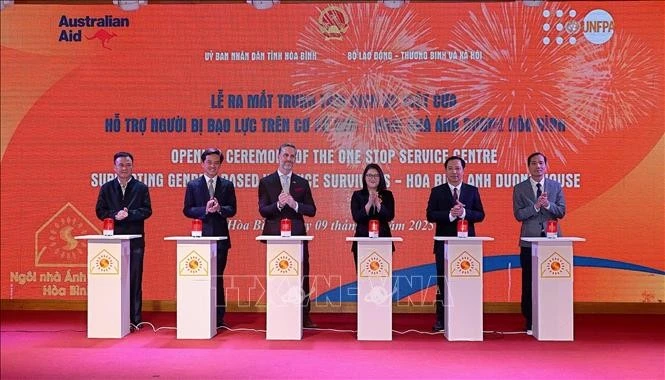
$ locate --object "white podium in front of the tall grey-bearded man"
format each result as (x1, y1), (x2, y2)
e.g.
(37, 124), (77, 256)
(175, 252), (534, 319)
(256, 235), (314, 340)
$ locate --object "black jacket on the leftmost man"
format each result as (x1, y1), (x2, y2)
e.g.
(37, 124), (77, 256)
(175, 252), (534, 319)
(95, 177), (152, 249)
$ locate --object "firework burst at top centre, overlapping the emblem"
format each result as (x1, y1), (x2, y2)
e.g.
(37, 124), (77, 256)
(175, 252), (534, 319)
(293, 3), (435, 166)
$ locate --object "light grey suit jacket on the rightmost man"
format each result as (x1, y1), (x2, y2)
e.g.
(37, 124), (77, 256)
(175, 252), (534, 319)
(513, 178), (566, 247)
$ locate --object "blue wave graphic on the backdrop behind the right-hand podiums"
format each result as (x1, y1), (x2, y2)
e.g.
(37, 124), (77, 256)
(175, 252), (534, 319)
(315, 255), (665, 302)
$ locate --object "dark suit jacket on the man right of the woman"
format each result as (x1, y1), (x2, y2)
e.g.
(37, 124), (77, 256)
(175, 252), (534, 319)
(427, 183), (485, 254)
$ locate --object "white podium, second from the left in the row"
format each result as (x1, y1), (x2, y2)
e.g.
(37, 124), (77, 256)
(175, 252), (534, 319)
(164, 236), (227, 339)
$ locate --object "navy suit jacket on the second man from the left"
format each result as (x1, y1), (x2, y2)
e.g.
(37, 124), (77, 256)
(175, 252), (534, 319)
(182, 176), (236, 248)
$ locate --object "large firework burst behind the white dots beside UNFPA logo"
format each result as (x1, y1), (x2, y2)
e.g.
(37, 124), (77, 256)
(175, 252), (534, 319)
(442, 2), (603, 169)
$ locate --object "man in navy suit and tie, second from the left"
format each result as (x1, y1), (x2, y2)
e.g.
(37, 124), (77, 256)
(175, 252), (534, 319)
(182, 148), (236, 326)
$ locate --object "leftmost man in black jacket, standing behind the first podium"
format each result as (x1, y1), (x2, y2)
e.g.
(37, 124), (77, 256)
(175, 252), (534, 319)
(95, 152), (152, 328)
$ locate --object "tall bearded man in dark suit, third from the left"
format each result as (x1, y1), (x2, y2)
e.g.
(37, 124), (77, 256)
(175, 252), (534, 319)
(259, 143), (317, 328)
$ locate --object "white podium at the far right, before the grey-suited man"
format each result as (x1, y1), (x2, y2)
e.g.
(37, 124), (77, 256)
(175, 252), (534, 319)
(522, 237), (586, 341)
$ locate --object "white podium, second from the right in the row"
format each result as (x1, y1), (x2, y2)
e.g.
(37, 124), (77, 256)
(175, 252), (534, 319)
(434, 236), (494, 341)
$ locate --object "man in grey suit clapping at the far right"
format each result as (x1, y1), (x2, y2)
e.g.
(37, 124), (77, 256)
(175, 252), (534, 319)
(513, 152), (566, 333)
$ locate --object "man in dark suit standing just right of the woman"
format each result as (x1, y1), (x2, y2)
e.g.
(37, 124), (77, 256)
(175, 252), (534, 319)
(427, 156), (485, 331)
